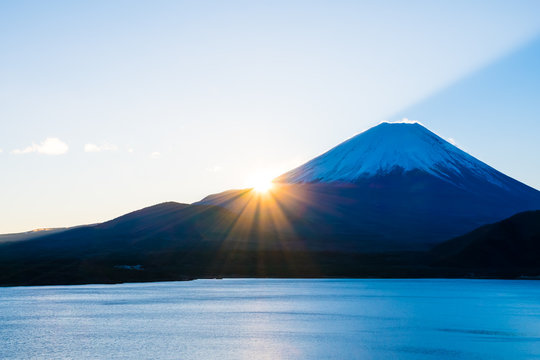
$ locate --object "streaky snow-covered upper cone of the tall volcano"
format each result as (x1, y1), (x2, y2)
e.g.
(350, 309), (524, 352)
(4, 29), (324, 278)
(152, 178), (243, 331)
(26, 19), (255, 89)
(275, 121), (504, 186)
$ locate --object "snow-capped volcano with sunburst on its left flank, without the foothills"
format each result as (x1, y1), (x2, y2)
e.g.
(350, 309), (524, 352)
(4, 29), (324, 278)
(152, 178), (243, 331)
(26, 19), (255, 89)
(199, 123), (540, 251)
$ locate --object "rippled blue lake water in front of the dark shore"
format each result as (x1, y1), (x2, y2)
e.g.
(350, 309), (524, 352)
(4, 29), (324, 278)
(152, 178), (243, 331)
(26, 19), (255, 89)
(0, 279), (540, 359)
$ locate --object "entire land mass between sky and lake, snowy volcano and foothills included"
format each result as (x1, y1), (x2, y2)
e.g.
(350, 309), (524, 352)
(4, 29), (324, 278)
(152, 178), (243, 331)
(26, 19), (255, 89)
(0, 123), (540, 286)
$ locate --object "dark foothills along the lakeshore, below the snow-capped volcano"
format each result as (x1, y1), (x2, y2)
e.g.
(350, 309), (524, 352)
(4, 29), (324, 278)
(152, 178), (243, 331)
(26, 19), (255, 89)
(0, 204), (540, 285)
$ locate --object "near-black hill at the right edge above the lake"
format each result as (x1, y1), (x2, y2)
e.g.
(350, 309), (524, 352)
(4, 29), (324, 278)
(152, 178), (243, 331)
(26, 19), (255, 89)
(430, 210), (540, 275)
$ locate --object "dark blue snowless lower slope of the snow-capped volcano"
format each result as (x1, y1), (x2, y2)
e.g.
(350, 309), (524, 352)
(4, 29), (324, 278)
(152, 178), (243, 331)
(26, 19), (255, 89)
(199, 176), (527, 251)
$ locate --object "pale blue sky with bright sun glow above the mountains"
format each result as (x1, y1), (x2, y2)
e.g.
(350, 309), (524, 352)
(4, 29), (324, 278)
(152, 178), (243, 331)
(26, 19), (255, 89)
(0, 0), (540, 233)
